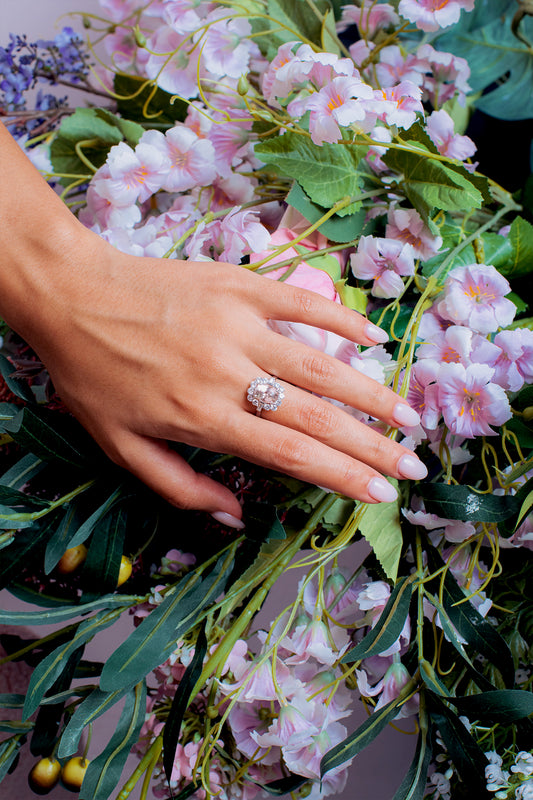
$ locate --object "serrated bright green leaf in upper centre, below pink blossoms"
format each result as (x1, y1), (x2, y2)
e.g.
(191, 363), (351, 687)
(255, 131), (366, 214)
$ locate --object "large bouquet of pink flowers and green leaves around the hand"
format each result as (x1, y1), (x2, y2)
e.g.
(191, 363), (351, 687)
(0, 0), (533, 800)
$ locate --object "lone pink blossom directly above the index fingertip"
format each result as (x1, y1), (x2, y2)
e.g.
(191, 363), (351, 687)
(350, 236), (415, 297)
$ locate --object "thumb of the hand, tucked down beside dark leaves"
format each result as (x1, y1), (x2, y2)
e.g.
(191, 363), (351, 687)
(121, 436), (243, 528)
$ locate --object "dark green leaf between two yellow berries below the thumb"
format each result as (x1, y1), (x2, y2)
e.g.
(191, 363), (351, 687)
(82, 506), (127, 600)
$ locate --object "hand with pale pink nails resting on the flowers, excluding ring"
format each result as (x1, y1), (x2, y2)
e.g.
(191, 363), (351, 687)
(16, 229), (426, 526)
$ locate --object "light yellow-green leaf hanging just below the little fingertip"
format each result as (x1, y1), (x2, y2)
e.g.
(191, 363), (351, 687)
(359, 488), (403, 581)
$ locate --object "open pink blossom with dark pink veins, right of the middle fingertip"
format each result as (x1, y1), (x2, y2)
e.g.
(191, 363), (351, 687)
(438, 363), (512, 439)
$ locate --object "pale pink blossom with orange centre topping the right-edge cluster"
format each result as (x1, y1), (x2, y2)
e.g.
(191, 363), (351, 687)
(437, 264), (516, 333)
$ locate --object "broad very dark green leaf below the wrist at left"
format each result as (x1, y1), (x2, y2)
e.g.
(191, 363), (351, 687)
(4, 406), (98, 467)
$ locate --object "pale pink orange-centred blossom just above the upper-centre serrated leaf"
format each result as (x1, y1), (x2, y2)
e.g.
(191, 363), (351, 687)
(306, 77), (372, 144)
